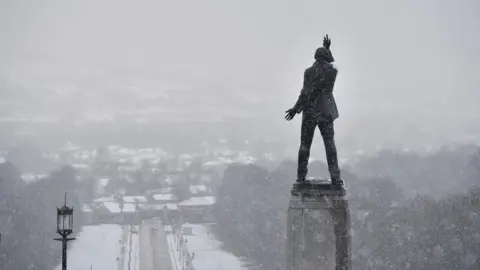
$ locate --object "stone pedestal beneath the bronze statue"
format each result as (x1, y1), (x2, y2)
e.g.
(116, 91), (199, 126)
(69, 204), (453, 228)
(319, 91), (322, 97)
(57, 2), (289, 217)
(286, 180), (351, 270)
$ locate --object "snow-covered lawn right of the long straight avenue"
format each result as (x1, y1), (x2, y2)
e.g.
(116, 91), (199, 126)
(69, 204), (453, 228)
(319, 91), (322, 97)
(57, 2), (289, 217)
(179, 223), (247, 270)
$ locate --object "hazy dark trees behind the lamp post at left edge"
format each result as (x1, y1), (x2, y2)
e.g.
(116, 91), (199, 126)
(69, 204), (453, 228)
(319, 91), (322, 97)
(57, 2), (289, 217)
(0, 162), (82, 270)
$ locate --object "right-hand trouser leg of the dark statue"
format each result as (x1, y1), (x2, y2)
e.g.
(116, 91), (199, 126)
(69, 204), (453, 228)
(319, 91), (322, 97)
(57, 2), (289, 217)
(318, 121), (340, 182)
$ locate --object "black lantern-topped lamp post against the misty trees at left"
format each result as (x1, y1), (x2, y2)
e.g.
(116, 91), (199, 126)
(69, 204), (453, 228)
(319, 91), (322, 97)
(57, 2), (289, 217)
(54, 193), (75, 270)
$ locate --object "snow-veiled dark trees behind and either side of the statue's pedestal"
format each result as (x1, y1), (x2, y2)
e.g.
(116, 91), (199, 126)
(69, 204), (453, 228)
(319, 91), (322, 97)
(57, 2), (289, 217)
(215, 148), (480, 270)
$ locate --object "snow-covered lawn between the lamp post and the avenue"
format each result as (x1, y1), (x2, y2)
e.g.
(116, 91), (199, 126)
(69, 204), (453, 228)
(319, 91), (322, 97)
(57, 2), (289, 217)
(55, 224), (139, 270)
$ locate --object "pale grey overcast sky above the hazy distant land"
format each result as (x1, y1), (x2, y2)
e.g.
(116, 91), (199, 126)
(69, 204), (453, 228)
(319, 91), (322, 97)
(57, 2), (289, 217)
(0, 0), (480, 149)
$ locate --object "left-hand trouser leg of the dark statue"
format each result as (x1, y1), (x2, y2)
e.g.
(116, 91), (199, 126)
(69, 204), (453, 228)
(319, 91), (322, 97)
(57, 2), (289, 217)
(297, 113), (317, 181)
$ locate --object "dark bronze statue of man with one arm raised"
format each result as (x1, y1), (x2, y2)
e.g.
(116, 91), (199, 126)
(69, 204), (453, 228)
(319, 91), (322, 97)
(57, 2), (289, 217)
(285, 35), (343, 188)
